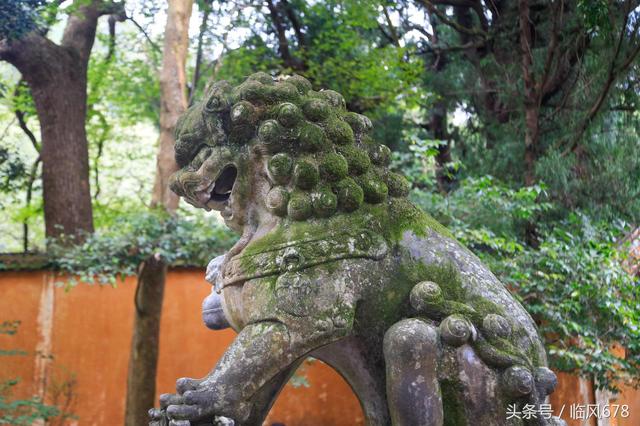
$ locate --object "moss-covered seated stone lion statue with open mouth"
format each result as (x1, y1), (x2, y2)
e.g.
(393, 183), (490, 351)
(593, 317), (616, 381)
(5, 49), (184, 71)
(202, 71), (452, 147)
(150, 73), (564, 426)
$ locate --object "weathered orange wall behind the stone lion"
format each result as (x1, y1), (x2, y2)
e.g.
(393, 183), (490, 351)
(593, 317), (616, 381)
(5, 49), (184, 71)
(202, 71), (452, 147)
(0, 269), (640, 426)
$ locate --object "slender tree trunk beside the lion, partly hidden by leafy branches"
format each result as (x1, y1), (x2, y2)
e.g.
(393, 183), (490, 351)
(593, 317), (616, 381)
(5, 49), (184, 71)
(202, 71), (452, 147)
(125, 0), (193, 426)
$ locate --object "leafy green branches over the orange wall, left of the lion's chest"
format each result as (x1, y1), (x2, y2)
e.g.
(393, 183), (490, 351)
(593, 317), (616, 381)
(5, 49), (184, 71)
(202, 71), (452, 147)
(49, 210), (235, 286)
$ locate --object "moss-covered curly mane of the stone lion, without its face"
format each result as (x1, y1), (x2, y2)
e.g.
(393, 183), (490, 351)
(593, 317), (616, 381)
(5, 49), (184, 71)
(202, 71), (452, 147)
(176, 72), (452, 237)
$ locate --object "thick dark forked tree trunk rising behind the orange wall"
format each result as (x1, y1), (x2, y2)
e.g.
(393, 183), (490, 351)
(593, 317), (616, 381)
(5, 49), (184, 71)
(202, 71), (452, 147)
(0, 0), (110, 241)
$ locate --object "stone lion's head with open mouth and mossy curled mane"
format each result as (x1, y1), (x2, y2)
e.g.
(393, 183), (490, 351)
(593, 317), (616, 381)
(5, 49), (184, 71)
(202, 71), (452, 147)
(171, 73), (409, 231)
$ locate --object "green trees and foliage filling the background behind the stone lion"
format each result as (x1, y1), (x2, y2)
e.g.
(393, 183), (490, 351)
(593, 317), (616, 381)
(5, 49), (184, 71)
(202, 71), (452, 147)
(0, 0), (640, 412)
